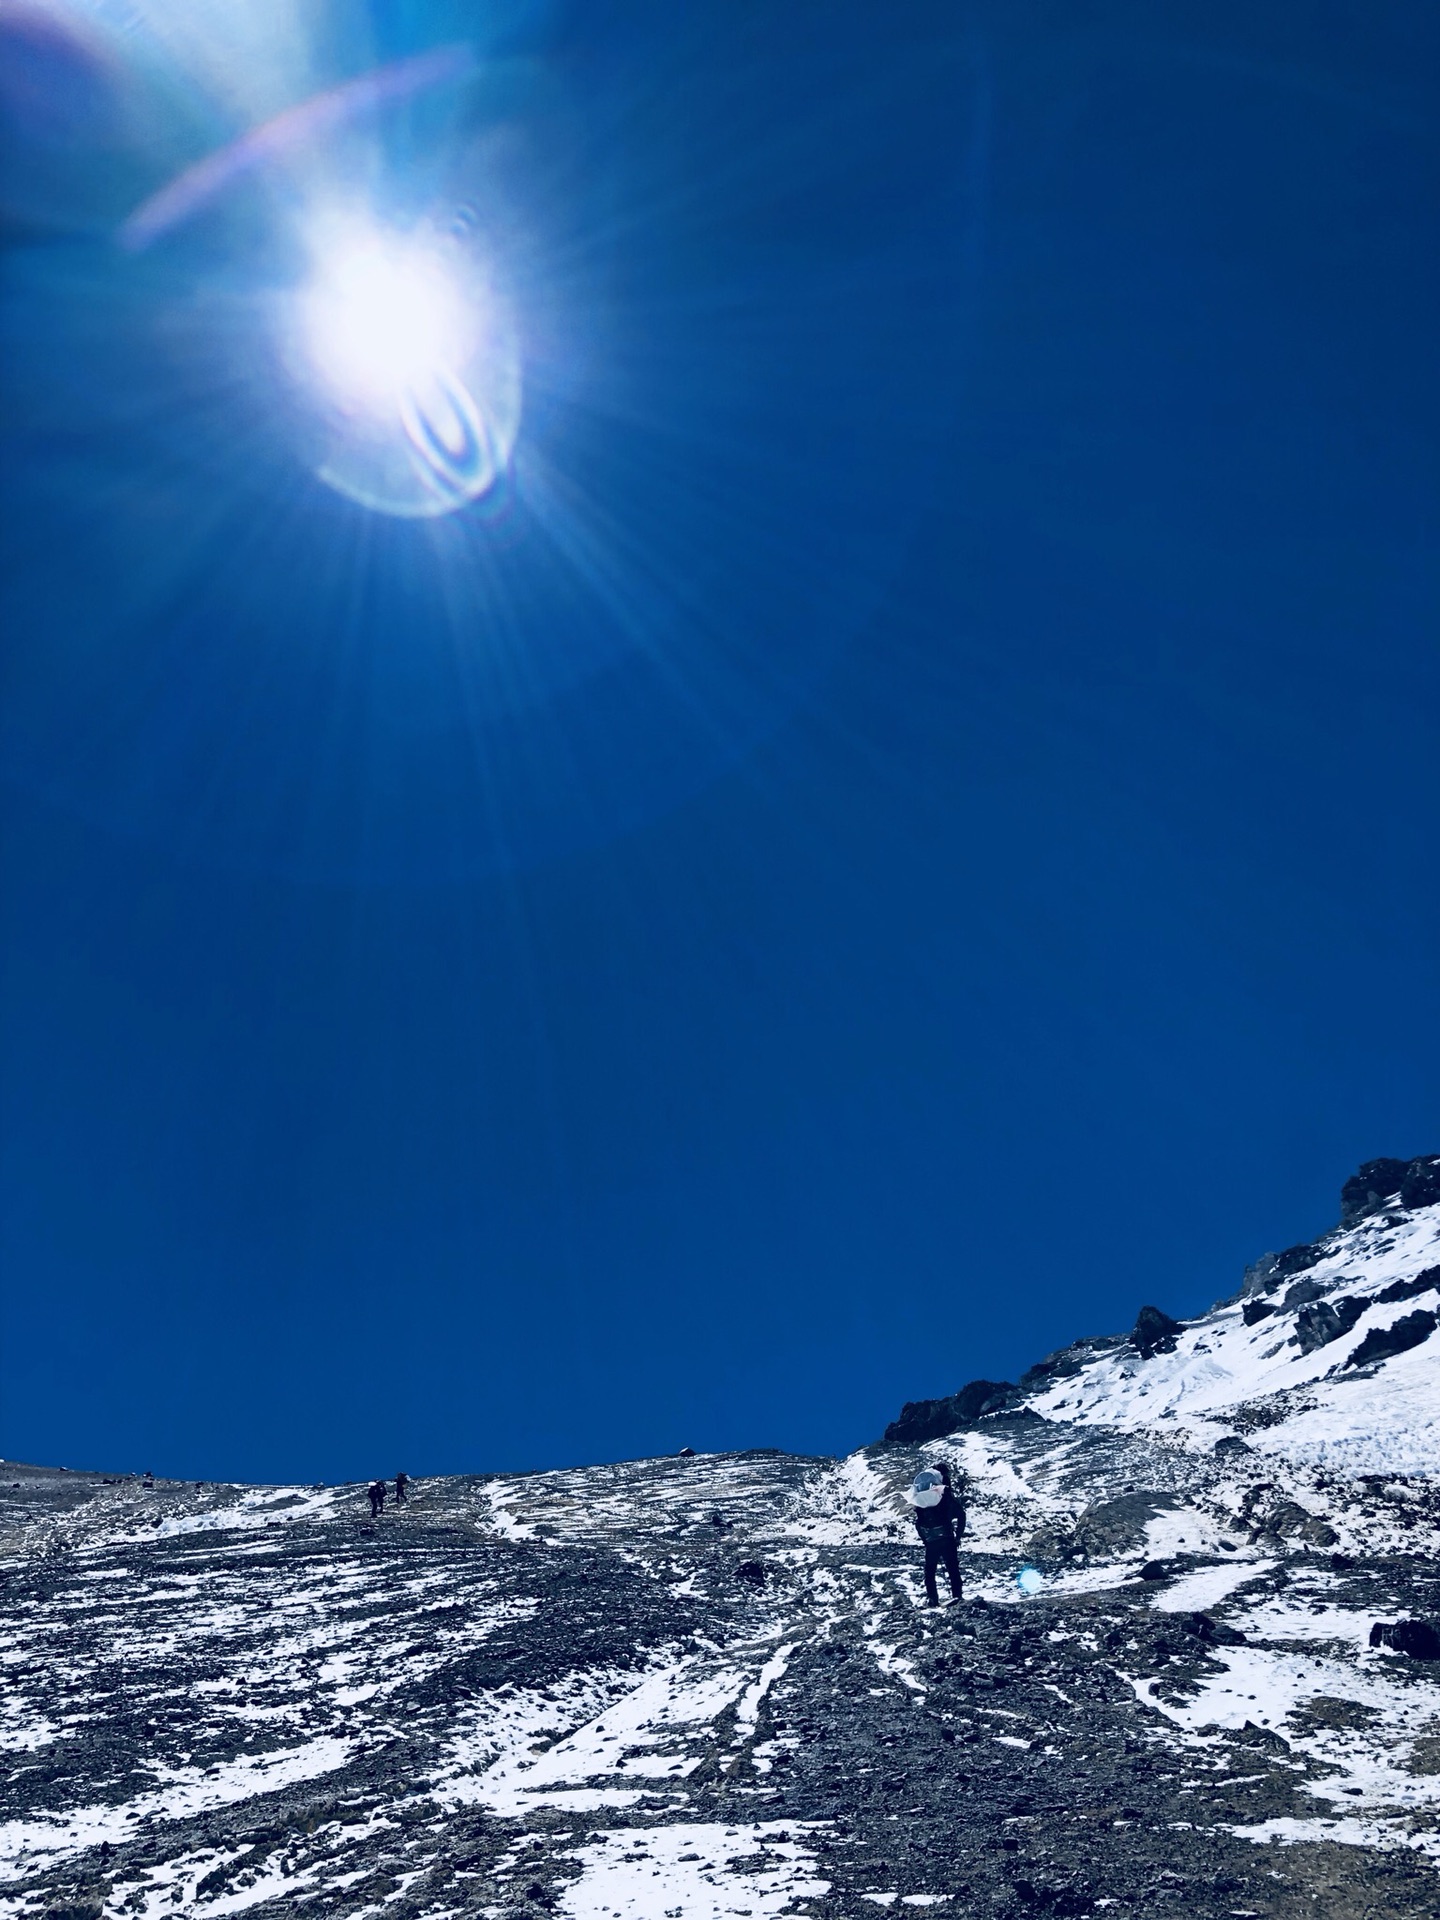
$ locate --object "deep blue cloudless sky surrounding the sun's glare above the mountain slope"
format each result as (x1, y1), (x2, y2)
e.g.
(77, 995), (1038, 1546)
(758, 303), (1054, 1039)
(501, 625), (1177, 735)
(0, 0), (1440, 1480)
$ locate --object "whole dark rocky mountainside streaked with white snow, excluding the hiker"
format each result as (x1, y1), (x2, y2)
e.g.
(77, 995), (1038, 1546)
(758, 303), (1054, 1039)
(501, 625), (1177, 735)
(0, 1160), (1440, 1920)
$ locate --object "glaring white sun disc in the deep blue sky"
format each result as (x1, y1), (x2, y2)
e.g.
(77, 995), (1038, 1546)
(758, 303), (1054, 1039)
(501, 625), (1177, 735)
(301, 230), (467, 411)
